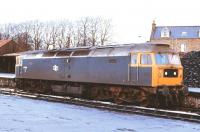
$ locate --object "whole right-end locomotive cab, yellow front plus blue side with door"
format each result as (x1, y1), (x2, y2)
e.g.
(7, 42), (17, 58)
(129, 52), (183, 87)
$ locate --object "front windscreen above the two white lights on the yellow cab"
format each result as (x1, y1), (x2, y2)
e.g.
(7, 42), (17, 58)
(155, 53), (180, 65)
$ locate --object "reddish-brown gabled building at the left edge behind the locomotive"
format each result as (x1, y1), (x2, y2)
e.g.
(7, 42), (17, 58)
(0, 39), (17, 55)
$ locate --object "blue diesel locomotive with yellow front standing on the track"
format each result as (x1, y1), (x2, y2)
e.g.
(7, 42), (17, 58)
(15, 43), (185, 106)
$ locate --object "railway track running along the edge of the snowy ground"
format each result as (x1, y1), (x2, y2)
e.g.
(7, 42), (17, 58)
(0, 88), (200, 123)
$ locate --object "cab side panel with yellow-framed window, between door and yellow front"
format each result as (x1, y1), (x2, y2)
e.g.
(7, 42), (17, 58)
(138, 53), (153, 86)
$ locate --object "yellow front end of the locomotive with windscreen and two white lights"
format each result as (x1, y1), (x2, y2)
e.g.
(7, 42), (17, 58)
(152, 53), (183, 87)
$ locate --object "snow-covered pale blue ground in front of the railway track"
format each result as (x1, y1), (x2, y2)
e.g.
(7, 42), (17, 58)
(0, 95), (200, 132)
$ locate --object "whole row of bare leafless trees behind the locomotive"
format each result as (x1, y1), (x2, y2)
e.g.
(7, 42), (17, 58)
(0, 17), (112, 51)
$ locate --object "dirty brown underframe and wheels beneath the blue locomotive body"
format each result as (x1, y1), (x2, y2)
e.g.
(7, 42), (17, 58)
(16, 79), (184, 107)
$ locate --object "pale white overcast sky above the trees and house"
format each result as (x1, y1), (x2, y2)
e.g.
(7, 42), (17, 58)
(0, 0), (200, 43)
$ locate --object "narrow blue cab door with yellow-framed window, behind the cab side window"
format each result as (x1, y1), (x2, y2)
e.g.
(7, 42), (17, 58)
(128, 53), (139, 85)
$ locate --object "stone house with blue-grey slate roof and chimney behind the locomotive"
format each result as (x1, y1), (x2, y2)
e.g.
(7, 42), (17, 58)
(150, 21), (200, 52)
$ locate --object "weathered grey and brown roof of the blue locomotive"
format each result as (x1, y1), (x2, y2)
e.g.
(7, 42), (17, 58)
(15, 43), (174, 57)
